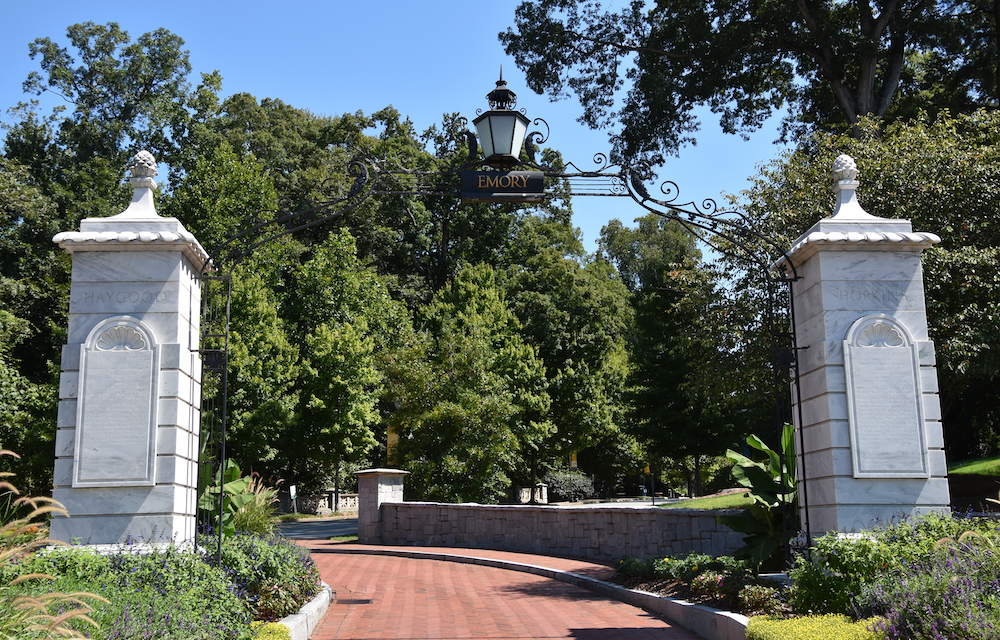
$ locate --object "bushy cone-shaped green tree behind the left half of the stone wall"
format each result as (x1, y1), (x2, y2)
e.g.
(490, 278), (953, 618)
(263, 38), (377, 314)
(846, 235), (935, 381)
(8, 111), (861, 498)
(389, 265), (552, 503)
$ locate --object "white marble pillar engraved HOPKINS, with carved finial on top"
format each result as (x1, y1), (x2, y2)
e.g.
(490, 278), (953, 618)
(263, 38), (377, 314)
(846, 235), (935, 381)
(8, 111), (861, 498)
(783, 156), (950, 533)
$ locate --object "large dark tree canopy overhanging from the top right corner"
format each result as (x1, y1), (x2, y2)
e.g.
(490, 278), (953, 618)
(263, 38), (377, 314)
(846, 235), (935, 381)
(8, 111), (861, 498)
(499, 0), (997, 159)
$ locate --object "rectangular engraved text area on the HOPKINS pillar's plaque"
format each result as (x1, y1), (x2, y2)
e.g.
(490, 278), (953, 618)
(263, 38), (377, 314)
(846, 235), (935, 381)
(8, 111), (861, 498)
(850, 347), (924, 473)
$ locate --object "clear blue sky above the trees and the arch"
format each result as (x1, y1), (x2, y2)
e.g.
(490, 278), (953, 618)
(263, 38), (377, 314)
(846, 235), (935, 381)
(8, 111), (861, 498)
(0, 0), (792, 250)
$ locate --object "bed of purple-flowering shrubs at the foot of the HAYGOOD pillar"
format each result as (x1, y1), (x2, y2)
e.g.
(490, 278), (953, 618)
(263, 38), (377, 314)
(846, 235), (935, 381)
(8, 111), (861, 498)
(0, 535), (319, 640)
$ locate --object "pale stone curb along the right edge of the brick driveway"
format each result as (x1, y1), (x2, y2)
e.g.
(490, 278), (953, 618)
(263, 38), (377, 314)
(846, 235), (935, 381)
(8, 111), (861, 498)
(312, 548), (748, 640)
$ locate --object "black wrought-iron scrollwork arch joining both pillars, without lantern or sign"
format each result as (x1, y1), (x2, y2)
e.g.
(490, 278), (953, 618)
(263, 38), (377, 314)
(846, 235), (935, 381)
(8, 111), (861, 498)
(198, 127), (811, 554)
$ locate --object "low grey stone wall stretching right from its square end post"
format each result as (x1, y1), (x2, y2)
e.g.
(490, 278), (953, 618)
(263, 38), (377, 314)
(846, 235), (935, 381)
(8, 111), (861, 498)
(379, 502), (743, 560)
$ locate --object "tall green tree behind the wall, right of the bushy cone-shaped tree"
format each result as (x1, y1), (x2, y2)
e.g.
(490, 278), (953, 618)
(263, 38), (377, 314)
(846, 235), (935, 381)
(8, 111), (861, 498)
(507, 216), (631, 480)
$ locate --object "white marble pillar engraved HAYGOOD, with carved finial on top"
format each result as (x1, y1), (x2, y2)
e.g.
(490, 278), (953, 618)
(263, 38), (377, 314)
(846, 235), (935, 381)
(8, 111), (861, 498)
(51, 151), (208, 544)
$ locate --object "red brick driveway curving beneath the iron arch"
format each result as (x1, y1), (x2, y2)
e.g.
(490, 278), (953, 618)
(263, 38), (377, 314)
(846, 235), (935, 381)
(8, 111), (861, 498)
(301, 541), (699, 640)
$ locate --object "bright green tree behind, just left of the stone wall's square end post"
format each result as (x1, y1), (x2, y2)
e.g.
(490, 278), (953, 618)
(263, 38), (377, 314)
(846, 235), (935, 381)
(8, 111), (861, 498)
(282, 230), (412, 488)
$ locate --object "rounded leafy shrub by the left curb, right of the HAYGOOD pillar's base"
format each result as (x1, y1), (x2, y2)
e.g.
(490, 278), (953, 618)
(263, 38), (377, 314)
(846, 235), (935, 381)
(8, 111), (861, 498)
(209, 535), (320, 620)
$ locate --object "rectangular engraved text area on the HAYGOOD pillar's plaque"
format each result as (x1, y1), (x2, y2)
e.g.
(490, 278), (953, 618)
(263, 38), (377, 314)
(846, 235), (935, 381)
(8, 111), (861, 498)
(76, 351), (154, 482)
